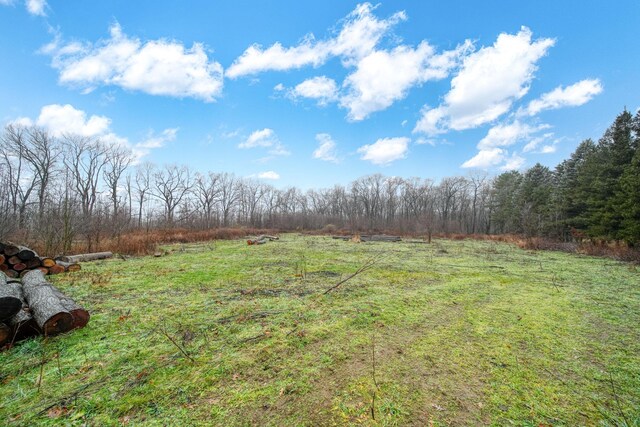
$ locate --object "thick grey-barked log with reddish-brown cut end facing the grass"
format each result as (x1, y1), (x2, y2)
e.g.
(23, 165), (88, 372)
(22, 270), (73, 336)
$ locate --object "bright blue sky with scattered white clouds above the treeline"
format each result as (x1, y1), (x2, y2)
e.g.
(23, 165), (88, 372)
(0, 0), (640, 188)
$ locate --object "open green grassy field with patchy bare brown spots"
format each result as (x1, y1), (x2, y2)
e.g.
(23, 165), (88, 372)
(0, 234), (640, 426)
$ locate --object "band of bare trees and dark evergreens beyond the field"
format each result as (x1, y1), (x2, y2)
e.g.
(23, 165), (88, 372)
(0, 110), (640, 253)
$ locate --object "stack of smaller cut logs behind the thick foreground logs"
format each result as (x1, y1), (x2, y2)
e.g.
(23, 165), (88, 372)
(0, 242), (80, 279)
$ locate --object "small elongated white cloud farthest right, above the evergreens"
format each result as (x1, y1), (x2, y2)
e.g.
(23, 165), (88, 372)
(524, 79), (603, 116)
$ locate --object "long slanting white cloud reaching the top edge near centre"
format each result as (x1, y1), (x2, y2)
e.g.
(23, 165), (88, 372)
(226, 3), (406, 79)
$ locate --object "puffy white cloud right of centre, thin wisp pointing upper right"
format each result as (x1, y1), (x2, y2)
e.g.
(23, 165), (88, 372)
(340, 41), (472, 121)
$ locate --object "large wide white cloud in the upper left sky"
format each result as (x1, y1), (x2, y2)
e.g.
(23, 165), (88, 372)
(42, 24), (223, 102)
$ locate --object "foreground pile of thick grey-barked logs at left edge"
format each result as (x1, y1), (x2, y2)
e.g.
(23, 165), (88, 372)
(0, 269), (89, 348)
